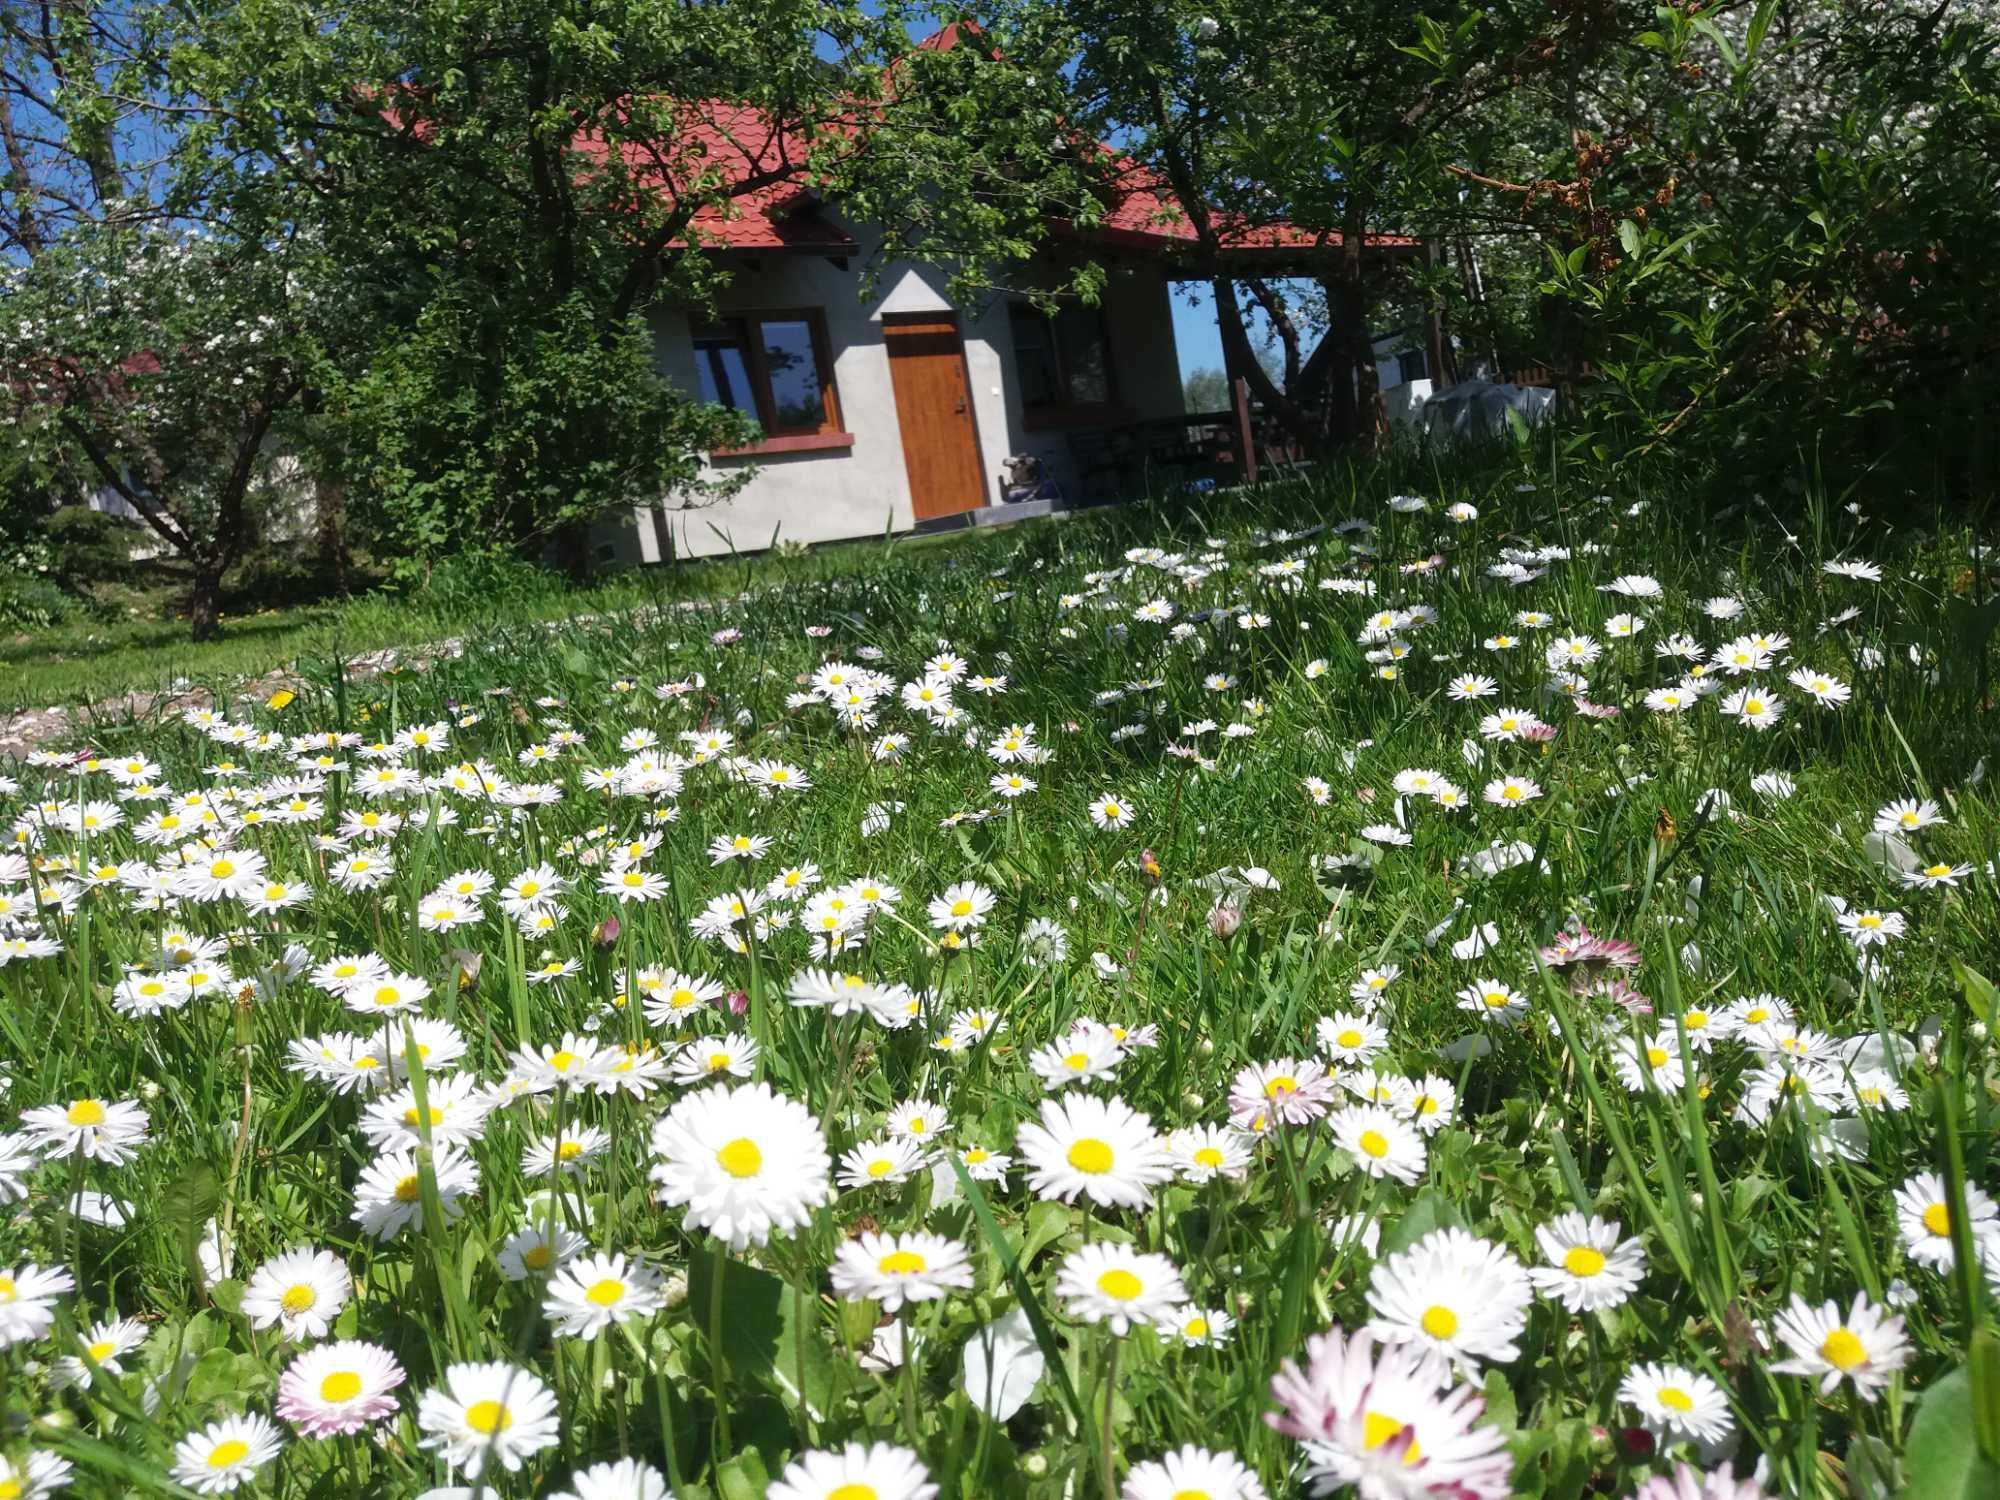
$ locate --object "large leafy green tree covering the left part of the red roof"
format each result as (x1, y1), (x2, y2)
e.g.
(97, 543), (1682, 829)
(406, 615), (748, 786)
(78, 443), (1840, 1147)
(174, 0), (1092, 568)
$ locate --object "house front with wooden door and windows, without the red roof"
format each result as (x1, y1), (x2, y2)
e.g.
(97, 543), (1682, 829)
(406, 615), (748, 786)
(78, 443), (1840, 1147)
(594, 210), (1182, 564)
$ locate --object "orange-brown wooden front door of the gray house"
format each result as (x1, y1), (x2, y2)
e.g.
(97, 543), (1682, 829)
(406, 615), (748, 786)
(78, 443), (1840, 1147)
(882, 312), (986, 520)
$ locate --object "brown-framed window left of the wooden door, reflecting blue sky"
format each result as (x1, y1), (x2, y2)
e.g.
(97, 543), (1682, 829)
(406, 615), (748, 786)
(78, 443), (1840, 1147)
(694, 308), (840, 440)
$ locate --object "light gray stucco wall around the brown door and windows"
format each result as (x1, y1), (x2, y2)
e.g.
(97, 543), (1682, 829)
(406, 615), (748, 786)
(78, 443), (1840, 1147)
(592, 226), (1182, 566)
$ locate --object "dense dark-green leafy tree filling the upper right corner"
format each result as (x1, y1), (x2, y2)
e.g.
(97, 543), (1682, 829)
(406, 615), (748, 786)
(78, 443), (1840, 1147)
(1420, 0), (2000, 500)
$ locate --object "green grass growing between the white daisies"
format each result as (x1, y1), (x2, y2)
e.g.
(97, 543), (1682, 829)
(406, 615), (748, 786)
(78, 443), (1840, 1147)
(0, 468), (2000, 1500)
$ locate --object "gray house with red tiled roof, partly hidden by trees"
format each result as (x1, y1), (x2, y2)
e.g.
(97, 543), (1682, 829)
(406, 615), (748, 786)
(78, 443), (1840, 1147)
(590, 40), (1412, 566)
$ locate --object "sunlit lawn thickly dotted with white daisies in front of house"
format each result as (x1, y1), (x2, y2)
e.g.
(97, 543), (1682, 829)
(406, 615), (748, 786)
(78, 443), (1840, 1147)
(0, 470), (2000, 1500)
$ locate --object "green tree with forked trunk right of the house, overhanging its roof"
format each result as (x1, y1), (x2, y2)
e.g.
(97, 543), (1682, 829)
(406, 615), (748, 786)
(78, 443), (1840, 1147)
(1010, 0), (1534, 448)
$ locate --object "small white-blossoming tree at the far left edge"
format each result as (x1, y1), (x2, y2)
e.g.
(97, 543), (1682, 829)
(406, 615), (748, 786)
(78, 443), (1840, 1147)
(0, 0), (348, 640)
